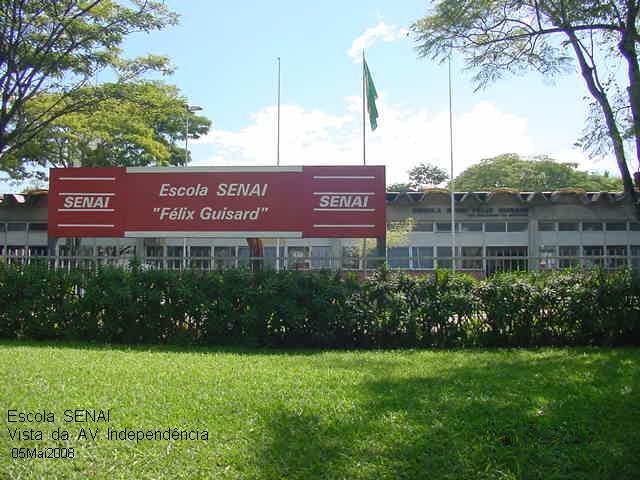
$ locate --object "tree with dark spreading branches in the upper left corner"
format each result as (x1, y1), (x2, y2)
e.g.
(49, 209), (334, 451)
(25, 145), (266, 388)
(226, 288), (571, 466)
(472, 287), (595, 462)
(0, 0), (177, 169)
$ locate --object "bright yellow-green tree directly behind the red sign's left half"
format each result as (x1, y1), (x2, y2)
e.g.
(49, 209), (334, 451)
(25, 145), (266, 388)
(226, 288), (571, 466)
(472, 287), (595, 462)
(5, 81), (211, 179)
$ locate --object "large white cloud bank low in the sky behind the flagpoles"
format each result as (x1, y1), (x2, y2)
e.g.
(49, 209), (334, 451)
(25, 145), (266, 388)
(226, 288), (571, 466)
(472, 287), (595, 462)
(192, 94), (536, 183)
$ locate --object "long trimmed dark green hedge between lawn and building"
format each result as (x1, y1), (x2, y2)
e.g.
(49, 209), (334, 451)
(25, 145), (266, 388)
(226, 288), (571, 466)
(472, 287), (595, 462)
(0, 265), (640, 348)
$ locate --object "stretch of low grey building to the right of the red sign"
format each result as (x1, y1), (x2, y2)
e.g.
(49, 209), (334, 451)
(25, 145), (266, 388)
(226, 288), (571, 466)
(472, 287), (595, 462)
(387, 190), (640, 274)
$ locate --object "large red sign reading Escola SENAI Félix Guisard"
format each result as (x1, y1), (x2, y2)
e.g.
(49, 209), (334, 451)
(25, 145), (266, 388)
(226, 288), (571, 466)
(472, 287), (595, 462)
(49, 166), (385, 238)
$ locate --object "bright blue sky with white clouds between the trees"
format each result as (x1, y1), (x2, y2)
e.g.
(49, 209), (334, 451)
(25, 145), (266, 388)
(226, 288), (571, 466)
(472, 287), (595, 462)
(0, 0), (617, 191)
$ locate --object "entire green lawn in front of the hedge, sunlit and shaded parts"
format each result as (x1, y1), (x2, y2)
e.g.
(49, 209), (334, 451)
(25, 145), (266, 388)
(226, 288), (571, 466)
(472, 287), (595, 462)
(0, 342), (640, 479)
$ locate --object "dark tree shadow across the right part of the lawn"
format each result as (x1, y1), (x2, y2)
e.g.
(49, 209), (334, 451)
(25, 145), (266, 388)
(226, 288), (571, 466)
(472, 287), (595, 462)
(253, 350), (640, 479)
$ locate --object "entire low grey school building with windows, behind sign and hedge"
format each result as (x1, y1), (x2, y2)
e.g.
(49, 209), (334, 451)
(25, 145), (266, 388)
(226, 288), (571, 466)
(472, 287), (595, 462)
(0, 189), (640, 275)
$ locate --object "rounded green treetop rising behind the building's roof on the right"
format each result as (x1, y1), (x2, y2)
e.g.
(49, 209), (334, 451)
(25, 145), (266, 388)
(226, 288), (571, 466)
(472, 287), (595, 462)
(455, 153), (622, 192)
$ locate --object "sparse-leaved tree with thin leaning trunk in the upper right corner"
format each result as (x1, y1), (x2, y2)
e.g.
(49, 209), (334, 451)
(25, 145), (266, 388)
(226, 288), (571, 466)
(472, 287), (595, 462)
(412, 0), (640, 200)
